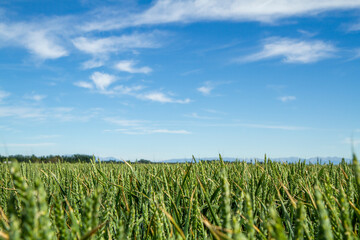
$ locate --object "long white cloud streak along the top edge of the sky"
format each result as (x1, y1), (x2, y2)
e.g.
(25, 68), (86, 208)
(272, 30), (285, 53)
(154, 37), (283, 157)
(84, 0), (360, 31)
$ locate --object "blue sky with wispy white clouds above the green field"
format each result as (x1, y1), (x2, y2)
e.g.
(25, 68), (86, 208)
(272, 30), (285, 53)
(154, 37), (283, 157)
(0, 0), (360, 161)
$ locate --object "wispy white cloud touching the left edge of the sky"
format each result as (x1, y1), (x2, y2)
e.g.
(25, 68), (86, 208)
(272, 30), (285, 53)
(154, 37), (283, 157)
(0, 23), (68, 59)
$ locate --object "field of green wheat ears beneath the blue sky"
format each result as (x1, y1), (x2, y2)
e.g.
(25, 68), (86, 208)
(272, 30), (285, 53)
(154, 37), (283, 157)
(0, 157), (360, 240)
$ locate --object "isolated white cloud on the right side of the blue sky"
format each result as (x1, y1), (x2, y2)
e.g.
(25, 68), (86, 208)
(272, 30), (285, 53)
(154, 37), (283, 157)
(240, 37), (336, 63)
